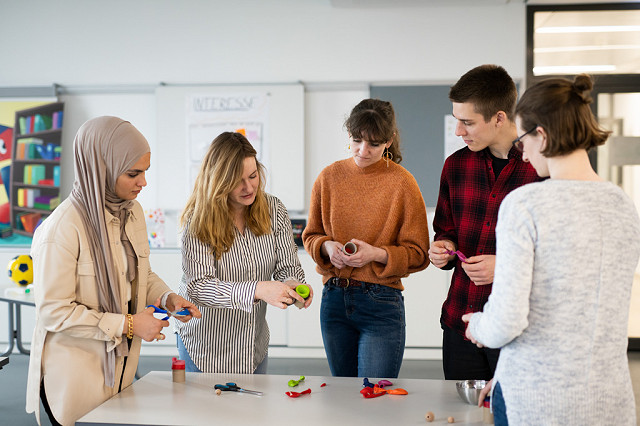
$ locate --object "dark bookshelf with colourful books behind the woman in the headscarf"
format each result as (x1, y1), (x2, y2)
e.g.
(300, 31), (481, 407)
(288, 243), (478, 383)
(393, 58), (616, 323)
(9, 102), (64, 236)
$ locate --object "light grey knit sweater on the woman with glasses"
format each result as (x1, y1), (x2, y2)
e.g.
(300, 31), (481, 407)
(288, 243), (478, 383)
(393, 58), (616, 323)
(469, 180), (640, 426)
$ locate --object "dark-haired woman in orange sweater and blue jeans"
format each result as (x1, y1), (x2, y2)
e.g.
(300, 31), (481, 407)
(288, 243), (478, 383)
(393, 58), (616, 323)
(302, 99), (429, 377)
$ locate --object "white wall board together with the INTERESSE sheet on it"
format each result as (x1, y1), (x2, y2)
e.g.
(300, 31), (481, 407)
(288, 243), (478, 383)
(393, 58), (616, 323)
(154, 83), (305, 211)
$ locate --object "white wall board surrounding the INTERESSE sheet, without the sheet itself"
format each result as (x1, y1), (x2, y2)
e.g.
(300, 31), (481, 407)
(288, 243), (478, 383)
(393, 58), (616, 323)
(154, 84), (305, 211)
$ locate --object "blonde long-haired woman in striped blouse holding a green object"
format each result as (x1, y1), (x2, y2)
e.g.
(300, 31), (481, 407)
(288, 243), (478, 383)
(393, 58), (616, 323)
(177, 132), (313, 373)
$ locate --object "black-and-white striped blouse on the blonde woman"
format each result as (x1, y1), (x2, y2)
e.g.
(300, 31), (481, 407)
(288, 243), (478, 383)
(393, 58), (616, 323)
(176, 194), (304, 373)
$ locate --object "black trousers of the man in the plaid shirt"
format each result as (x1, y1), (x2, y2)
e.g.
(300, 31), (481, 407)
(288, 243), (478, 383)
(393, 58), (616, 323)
(442, 325), (500, 380)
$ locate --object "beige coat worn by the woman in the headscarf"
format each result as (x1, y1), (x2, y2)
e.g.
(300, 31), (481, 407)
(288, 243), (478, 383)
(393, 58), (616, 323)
(26, 199), (170, 425)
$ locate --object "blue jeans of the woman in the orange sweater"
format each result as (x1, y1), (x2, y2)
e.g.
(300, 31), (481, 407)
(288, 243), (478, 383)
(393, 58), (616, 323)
(320, 281), (405, 378)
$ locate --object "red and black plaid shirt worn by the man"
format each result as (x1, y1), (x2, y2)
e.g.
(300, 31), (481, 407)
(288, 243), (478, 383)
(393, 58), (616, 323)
(433, 147), (540, 335)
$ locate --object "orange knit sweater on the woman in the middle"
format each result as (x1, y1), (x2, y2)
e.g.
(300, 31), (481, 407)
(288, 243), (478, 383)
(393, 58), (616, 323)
(302, 158), (429, 290)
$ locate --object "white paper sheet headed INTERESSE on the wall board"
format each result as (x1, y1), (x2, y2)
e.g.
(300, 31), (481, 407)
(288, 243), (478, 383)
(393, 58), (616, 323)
(186, 93), (270, 193)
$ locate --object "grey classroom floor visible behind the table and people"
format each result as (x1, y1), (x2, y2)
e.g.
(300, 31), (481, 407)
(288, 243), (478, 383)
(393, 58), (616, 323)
(0, 352), (640, 426)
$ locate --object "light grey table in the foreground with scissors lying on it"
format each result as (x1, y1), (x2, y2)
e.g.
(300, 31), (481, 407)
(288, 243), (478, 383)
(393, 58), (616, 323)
(76, 371), (482, 426)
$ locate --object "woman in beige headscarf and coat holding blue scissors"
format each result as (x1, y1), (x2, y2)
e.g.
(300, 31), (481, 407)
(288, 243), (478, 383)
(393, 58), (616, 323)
(26, 117), (200, 424)
